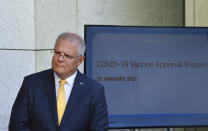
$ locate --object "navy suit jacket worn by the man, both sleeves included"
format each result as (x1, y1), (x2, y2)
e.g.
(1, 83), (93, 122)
(9, 69), (108, 131)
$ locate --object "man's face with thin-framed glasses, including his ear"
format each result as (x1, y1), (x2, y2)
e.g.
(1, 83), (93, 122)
(52, 39), (84, 79)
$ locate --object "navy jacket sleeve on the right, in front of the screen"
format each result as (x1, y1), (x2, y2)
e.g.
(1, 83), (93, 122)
(90, 86), (108, 131)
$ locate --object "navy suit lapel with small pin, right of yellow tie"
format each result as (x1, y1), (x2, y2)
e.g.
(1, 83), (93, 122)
(61, 71), (84, 125)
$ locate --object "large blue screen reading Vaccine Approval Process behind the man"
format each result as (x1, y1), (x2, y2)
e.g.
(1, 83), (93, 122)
(85, 25), (208, 128)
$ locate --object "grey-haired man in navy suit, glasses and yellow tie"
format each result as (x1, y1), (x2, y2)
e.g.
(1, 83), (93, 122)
(9, 33), (108, 131)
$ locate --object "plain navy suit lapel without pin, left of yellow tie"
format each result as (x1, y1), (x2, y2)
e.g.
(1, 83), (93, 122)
(44, 69), (58, 126)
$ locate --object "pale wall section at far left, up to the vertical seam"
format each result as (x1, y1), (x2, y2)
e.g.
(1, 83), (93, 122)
(0, 0), (35, 131)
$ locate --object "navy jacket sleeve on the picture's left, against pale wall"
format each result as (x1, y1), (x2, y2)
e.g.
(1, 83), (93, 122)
(9, 78), (30, 131)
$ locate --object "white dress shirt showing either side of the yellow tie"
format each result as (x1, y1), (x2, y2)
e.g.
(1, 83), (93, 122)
(54, 71), (77, 104)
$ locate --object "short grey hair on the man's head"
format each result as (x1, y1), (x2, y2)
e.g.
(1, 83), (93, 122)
(55, 32), (86, 56)
